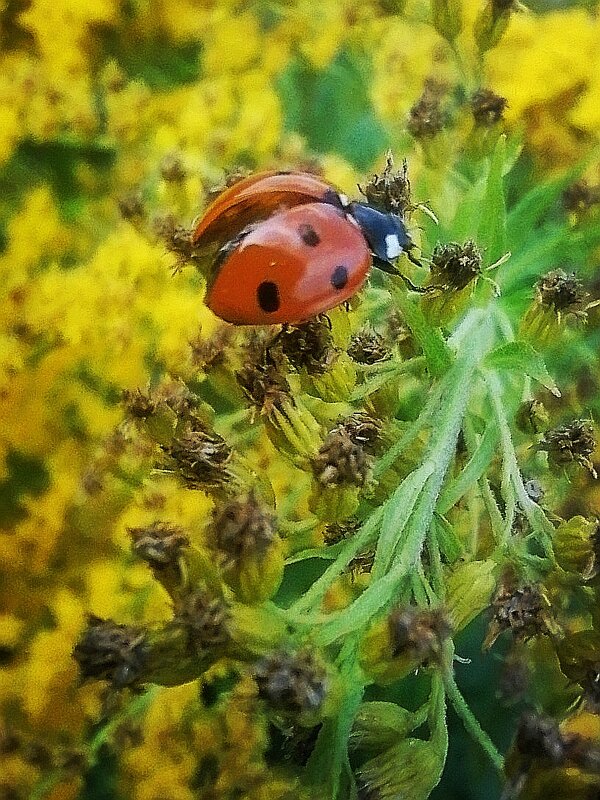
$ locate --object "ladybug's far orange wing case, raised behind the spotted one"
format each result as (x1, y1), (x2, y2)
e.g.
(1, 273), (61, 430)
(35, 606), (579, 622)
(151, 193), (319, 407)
(192, 172), (342, 247)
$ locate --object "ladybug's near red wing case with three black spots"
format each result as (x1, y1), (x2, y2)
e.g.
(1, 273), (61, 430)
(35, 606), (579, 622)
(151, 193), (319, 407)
(206, 203), (371, 325)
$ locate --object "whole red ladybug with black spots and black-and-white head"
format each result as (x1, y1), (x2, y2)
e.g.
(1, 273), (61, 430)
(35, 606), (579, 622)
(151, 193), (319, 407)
(192, 172), (418, 325)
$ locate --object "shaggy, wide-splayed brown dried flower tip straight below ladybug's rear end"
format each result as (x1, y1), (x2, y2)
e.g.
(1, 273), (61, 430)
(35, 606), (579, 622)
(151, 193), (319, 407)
(161, 420), (231, 489)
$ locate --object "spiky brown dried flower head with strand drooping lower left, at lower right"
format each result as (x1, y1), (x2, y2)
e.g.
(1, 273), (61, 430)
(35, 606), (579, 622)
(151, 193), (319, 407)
(484, 580), (554, 648)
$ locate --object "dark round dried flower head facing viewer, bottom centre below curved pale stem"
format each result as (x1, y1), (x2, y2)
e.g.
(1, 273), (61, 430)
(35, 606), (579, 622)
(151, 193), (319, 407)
(254, 650), (328, 718)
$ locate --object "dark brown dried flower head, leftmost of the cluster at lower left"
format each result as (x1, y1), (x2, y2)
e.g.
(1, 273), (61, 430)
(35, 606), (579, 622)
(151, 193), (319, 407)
(73, 616), (149, 689)
